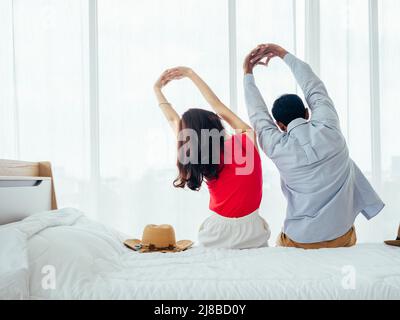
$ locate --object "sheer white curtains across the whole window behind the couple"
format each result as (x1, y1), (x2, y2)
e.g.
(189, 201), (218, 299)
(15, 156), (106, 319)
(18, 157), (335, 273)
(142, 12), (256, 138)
(0, 0), (400, 241)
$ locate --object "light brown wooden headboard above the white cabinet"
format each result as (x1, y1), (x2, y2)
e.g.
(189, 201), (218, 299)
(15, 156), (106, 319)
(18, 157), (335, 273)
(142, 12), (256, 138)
(0, 159), (57, 210)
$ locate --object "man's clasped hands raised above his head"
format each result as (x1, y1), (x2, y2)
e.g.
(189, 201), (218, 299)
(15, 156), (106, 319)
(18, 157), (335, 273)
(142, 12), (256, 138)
(243, 44), (288, 73)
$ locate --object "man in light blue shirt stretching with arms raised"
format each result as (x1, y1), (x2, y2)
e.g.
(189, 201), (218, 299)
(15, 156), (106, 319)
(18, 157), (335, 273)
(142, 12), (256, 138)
(244, 44), (384, 248)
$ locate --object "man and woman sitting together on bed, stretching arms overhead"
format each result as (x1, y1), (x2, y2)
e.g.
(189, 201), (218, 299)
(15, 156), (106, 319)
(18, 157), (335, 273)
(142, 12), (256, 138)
(154, 44), (384, 249)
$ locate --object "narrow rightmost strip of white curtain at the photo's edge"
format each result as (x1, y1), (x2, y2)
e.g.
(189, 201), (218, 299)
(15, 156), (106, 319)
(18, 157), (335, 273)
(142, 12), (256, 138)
(378, 0), (400, 240)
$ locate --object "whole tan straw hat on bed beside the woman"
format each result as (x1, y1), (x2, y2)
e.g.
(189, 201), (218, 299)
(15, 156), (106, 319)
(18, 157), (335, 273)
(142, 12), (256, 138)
(124, 224), (193, 252)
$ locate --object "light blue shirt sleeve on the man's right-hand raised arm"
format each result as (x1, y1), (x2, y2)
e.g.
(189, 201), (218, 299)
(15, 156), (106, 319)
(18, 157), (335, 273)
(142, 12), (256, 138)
(284, 53), (339, 125)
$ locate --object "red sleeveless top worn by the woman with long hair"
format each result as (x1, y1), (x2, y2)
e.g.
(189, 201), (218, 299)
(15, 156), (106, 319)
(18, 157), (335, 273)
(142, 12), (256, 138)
(207, 133), (262, 218)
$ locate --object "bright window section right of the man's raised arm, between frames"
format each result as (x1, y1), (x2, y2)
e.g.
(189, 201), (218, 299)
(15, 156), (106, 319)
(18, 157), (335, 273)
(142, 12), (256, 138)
(320, 0), (371, 177)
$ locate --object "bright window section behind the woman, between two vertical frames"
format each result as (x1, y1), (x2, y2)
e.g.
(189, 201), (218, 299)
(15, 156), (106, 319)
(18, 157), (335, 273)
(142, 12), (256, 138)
(98, 0), (229, 237)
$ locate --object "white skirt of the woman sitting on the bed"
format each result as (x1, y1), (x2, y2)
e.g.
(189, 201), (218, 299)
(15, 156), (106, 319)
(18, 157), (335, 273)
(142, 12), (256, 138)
(199, 210), (271, 249)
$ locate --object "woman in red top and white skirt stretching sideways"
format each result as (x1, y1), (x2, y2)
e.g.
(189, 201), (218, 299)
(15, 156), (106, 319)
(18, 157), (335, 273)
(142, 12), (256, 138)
(154, 67), (270, 249)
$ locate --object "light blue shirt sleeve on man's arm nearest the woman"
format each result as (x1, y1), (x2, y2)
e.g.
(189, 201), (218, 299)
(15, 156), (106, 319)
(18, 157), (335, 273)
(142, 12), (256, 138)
(244, 74), (282, 157)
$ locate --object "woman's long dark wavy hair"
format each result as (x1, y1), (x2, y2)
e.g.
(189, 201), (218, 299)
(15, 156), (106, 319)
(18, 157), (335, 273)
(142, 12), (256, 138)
(174, 109), (224, 191)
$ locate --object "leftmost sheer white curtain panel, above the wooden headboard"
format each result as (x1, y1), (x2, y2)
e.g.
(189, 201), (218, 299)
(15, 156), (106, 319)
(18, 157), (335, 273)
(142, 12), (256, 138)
(0, 0), (90, 209)
